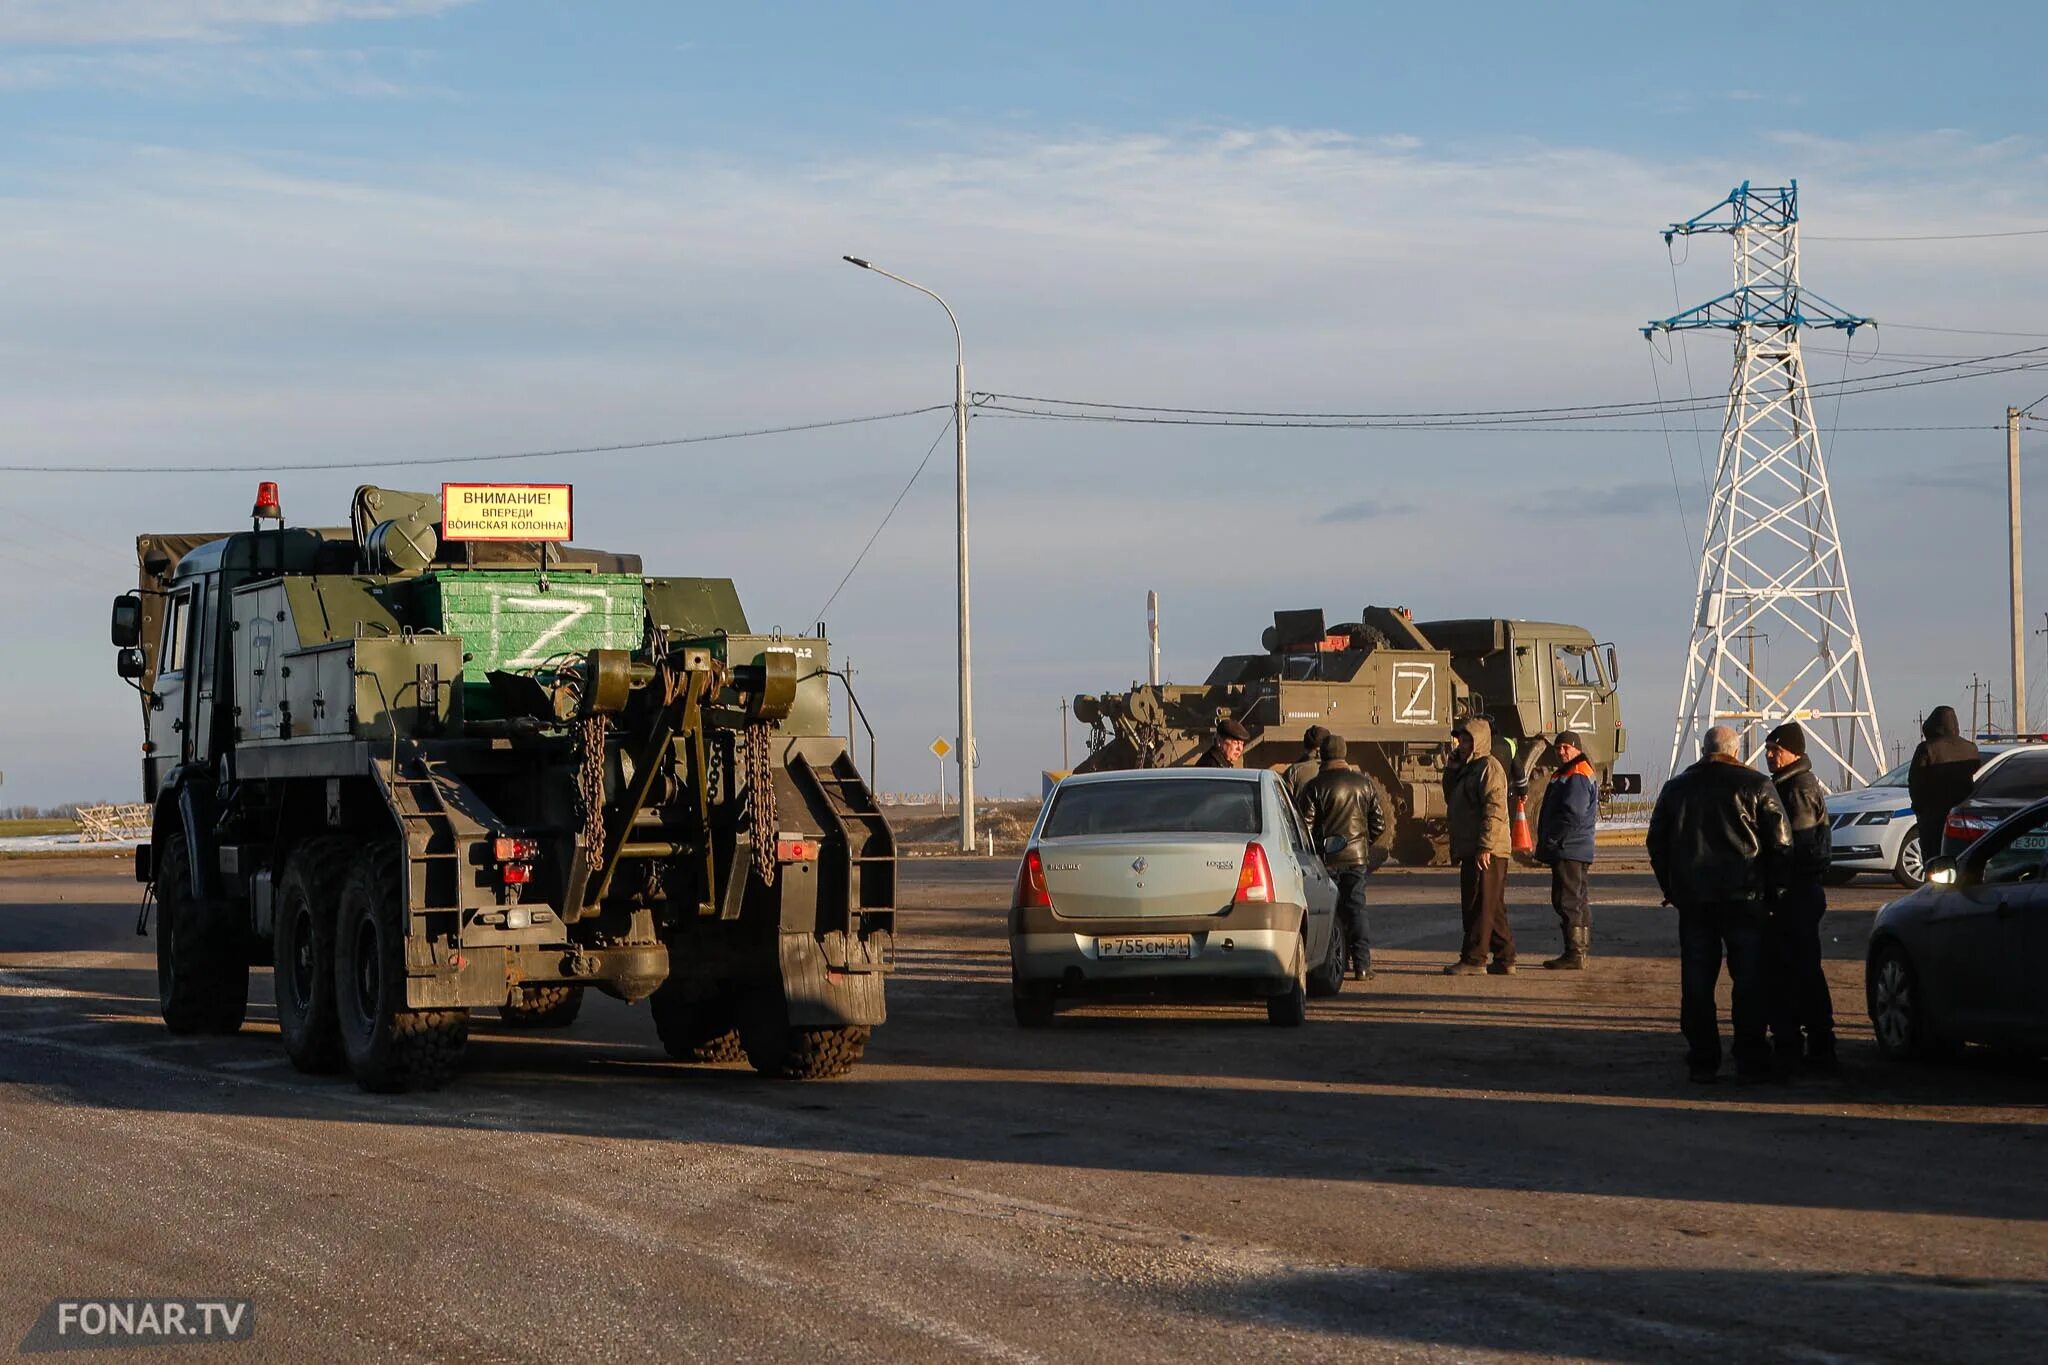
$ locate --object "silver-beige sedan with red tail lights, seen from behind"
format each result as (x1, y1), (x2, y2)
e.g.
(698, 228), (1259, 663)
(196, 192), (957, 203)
(1010, 767), (1343, 1027)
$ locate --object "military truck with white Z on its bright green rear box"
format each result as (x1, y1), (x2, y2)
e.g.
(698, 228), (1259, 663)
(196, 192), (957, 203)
(113, 483), (895, 1091)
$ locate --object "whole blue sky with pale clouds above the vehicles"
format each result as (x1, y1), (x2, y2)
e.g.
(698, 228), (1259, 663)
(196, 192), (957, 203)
(0, 0), (2048, 804)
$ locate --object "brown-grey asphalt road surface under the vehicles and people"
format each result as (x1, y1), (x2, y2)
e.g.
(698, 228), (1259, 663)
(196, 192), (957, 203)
(0, 860), (2048, 1363)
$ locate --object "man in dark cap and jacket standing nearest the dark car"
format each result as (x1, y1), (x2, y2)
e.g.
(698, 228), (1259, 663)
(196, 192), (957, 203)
(1763, 722), (1841, 1074)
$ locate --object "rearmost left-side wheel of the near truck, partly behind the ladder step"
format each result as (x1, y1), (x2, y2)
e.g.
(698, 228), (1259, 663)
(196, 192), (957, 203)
(334, 841), (469, 1093)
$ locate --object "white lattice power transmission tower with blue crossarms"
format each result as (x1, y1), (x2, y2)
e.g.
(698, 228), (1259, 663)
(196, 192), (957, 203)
(1642, 180), (1884, 786)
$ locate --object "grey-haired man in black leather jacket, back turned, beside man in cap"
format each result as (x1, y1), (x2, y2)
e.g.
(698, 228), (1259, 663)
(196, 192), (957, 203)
(1649, 724), (1792, 1083)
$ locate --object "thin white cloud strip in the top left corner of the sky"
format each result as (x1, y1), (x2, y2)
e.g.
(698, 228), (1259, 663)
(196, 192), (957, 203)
(0, 0), (469, 47)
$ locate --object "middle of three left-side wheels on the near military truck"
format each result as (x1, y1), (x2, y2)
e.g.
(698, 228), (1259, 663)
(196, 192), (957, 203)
(270, 835), (356, 1076)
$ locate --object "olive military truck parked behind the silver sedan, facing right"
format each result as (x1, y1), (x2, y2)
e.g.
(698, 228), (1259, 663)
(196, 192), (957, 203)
(1073, 606), (1640, 864)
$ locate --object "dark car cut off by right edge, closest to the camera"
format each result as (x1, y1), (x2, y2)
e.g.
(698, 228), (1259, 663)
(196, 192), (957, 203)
(1864, 794), (2048, 1058)
